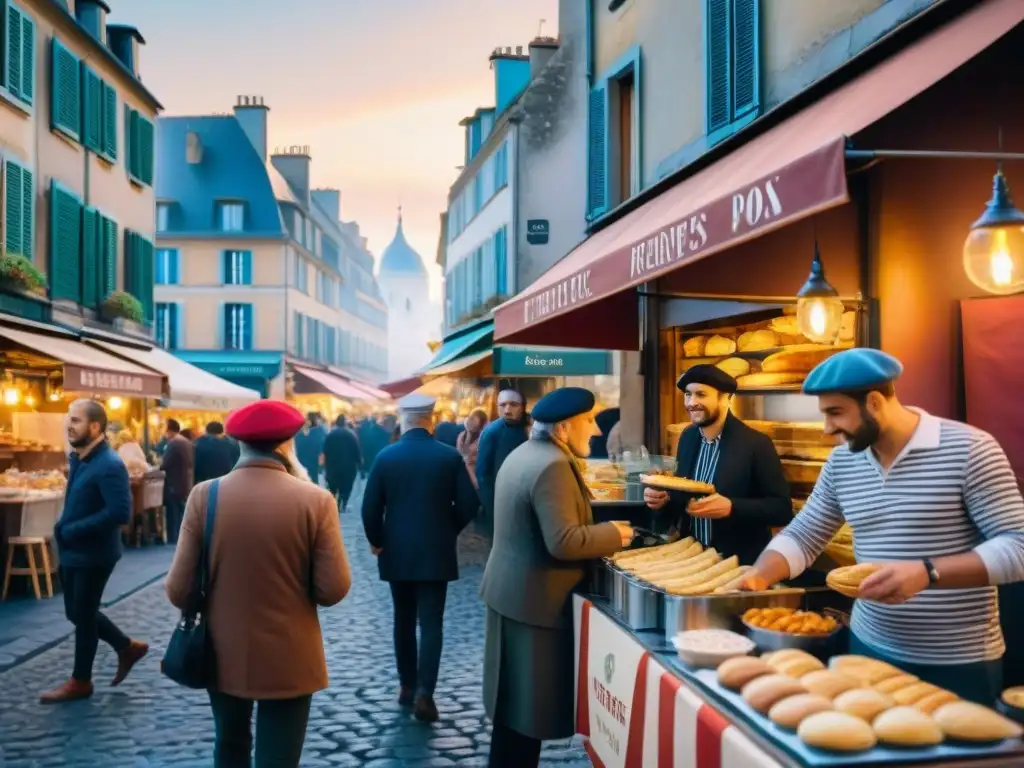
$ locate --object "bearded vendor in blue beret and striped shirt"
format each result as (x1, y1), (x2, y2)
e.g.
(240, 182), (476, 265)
(743, 349), (1024, 705)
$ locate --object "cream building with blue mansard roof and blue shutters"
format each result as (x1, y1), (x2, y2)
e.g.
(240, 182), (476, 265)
(155, 96), (388, 396)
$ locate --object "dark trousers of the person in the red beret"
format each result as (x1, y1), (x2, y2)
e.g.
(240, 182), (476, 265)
(210, 690), (312, 768)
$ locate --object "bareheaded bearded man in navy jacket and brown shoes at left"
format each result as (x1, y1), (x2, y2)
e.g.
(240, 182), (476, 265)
(40, 399), (150, 703)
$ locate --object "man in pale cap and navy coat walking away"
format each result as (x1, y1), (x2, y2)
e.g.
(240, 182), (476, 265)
(362, 394), (479, 722)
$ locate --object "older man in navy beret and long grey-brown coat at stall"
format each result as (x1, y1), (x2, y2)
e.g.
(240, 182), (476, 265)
(480, 387), (633, 768)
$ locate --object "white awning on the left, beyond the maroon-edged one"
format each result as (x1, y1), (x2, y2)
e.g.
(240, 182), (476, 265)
(89, 339), (260, 412)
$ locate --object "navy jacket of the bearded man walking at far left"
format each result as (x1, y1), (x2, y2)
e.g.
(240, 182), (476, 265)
(54, 440), (131, 568)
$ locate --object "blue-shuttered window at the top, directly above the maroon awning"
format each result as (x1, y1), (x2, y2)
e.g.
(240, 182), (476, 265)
(705, 0), (761, 144)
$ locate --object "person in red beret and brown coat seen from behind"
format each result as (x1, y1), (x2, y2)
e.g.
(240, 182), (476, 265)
(161, 400), (351, 768)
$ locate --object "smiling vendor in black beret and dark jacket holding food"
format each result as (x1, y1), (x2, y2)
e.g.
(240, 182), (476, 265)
(644, 365), (793, 565)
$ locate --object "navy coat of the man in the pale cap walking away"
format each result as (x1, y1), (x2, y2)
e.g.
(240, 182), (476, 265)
(362, 429), (479, 582)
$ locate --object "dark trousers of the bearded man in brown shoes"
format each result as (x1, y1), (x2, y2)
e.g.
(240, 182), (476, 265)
(60, 565), (131, 682)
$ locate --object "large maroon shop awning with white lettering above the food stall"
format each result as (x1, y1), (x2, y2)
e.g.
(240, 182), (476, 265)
(495, 0), (1024, 349)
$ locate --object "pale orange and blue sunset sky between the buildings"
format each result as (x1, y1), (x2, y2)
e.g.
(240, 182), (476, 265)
(111, 0), (558, 290)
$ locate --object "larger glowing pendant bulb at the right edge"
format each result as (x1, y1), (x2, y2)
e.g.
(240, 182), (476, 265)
(964, 166), (1024, 296)
